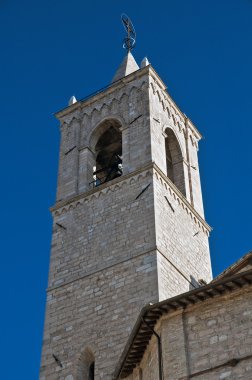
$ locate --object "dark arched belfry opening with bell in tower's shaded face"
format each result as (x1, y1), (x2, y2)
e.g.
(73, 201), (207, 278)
(93, 120), (122, 186)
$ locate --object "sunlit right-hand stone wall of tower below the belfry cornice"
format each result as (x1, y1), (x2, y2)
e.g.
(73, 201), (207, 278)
(154, 166), (212, 300)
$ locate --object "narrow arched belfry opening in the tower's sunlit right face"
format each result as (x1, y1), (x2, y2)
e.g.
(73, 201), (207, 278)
(165, 128), (186, 196)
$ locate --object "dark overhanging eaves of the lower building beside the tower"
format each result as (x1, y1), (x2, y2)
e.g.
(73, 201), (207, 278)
(113, 266), (252, 379)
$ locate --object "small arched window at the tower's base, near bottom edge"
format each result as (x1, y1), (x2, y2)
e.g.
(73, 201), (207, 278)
(76, 348), (95, 380)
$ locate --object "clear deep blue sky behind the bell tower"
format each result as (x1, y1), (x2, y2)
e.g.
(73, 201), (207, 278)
(0, 0), (252, 380)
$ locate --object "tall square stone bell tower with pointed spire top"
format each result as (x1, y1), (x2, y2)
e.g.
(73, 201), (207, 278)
(40, 52), (211, 380)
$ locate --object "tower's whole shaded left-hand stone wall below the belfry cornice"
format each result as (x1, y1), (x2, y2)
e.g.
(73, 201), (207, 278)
(41, 170), (158, 380)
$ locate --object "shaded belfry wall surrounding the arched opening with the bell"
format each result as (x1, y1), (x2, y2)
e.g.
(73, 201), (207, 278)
(57, 71), (151, 201)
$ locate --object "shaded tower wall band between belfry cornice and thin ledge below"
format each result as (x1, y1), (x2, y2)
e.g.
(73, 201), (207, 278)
(49, 170), (155, 287)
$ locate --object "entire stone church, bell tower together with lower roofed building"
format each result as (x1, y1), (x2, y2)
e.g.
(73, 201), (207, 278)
(40, 52), (252, 380)
